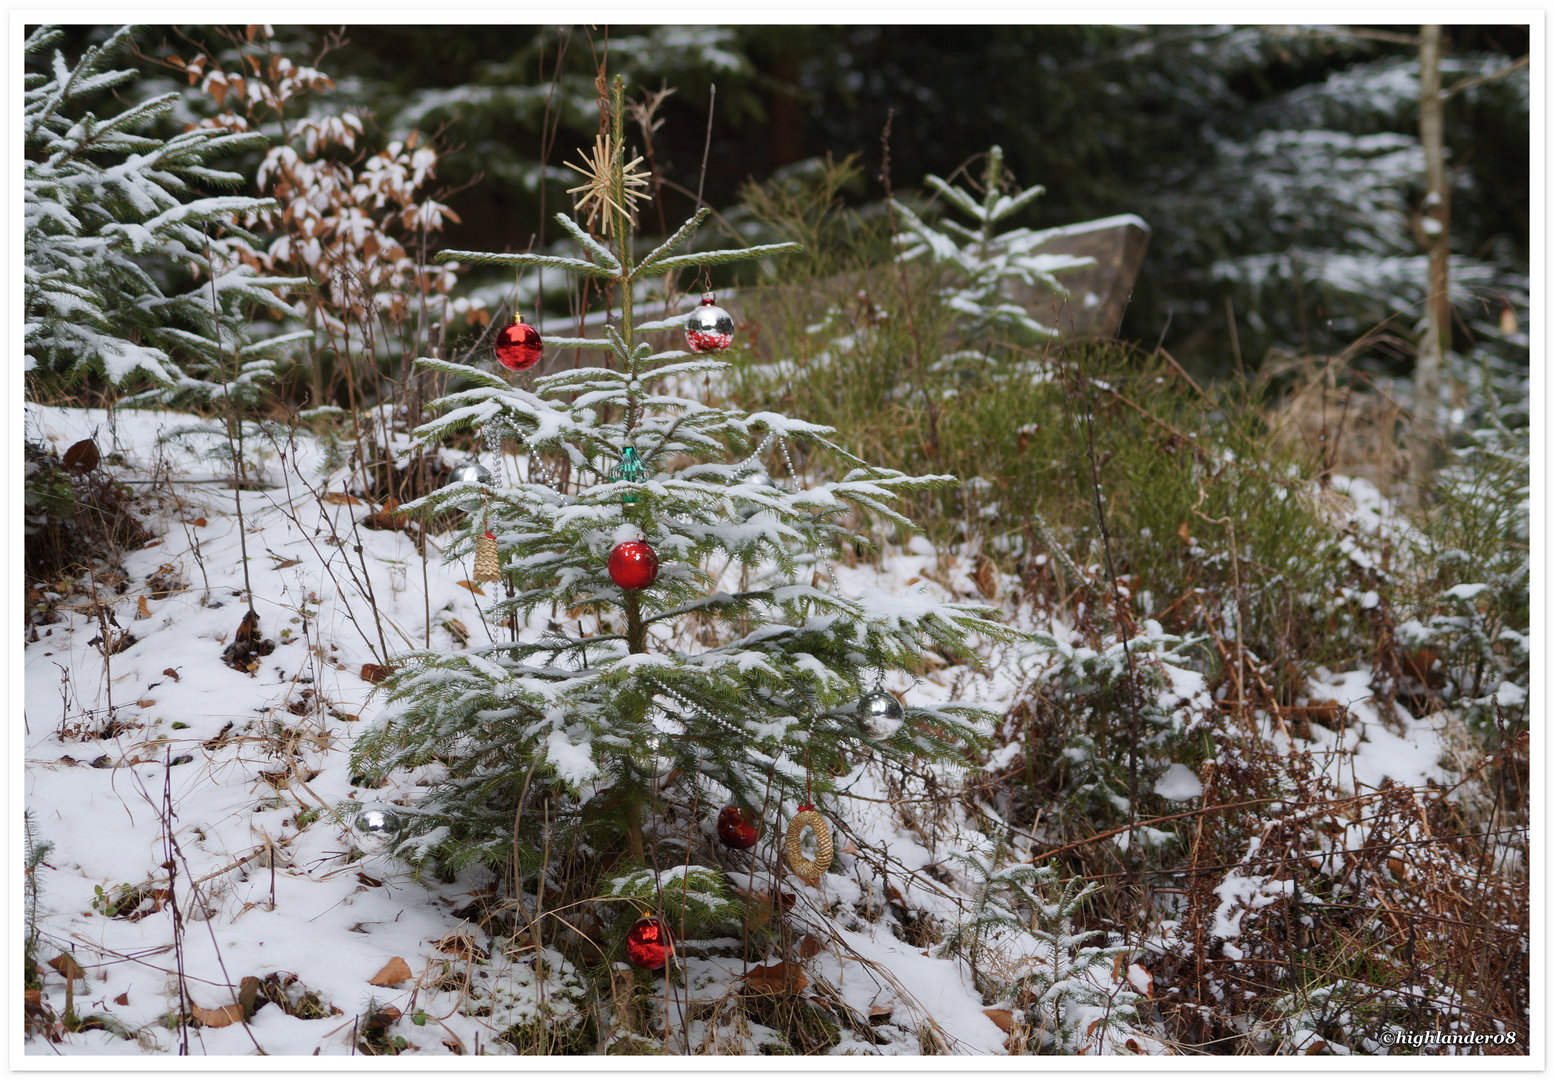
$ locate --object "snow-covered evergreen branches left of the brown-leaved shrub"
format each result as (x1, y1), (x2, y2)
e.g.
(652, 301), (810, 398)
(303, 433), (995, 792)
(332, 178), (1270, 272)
(22, 26), (300, 396)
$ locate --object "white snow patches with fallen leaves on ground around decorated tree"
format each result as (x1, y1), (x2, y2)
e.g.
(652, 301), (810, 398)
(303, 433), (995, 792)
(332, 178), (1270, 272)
(22, 406), (1439, 1055)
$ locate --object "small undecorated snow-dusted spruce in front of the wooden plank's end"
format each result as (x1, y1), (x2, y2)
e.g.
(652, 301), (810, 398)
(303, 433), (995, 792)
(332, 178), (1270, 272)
(890, 146), (1094, 342)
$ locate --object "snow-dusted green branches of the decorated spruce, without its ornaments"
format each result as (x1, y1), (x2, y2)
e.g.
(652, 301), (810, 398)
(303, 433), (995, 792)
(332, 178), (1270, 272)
(356, 92), (1007, 888)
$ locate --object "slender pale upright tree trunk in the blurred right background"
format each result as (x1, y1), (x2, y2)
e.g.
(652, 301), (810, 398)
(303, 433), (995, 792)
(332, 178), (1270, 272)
(1413, 26), (1451, 496)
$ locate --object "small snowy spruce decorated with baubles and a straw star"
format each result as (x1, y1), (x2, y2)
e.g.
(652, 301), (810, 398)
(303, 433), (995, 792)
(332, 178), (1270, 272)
(354, 79), (1007, 968)
